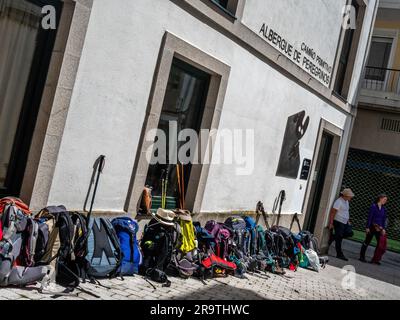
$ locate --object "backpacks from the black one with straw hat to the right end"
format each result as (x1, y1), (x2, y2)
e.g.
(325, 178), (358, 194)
(139, 203), (328, 286)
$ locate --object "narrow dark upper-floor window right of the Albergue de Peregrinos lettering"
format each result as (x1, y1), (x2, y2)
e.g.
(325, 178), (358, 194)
(334, 0), (365, 98)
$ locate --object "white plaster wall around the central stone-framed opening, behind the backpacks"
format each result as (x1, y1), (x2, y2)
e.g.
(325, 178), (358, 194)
(44, 0), (374, 212)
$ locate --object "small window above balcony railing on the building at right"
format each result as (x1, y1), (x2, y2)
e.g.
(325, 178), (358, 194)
(365, 37), (393, 81)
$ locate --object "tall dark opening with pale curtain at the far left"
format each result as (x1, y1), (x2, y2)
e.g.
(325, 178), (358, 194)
(0, 0), (62, 197)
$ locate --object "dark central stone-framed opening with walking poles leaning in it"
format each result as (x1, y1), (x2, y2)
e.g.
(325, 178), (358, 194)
(146, 58), (211, 210)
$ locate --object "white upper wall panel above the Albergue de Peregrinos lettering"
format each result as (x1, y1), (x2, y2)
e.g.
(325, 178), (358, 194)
(243, 0), (346, 87)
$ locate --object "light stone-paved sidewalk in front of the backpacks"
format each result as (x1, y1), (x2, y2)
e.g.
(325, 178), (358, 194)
(0, 241), (400, 300)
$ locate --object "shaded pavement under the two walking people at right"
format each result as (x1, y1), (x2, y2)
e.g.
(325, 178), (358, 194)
(329, 240), (400, 286)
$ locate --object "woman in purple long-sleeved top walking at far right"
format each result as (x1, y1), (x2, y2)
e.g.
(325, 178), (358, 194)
(360, 194), (387, 264)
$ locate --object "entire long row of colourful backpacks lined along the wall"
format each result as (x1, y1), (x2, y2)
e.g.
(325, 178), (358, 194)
(0, 197), (327, 288)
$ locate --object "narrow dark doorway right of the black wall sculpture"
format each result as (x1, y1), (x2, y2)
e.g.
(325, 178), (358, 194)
(304, 131), (334, 233)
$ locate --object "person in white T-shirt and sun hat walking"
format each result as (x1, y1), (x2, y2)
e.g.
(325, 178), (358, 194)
(329, 188), (354, 261)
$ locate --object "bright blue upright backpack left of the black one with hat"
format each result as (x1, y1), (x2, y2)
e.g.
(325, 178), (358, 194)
(111, 217), (142, 275)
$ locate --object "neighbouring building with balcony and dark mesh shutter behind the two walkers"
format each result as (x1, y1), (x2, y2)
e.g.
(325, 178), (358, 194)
(343, 0), (400, 249)
